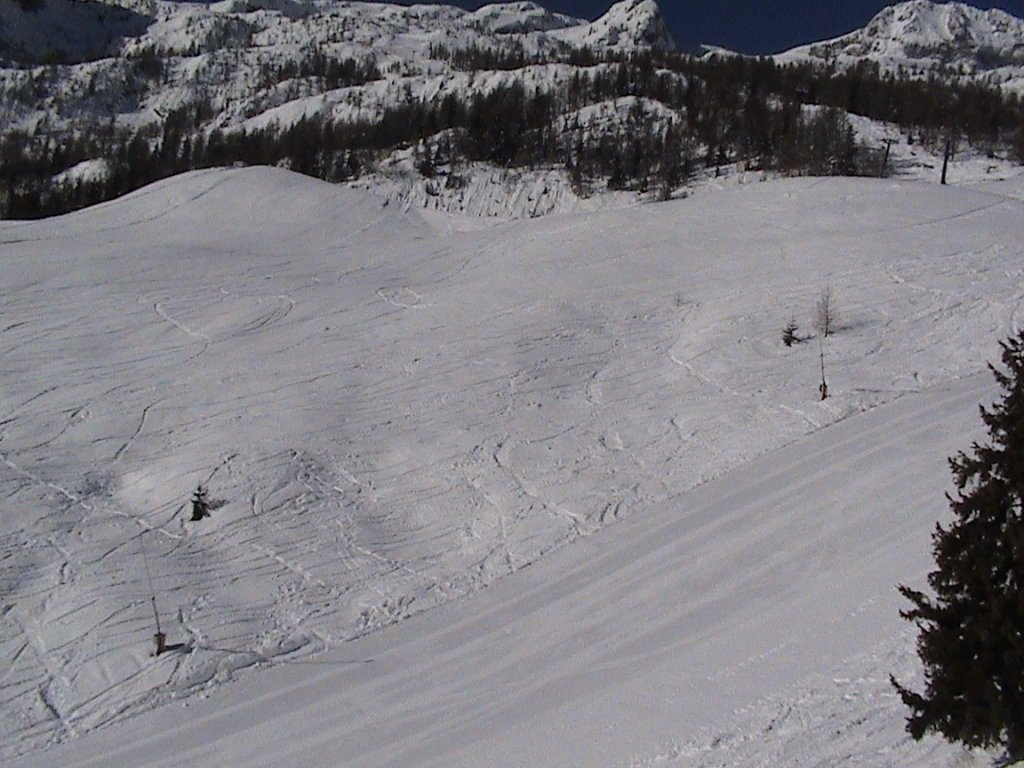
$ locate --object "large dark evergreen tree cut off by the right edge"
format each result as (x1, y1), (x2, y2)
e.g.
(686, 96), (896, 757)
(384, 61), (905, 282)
(893, 331), (1024, 762)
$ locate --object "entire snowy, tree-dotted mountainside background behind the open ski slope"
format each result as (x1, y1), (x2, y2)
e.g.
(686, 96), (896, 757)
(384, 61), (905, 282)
(0, 0), (1024, 219)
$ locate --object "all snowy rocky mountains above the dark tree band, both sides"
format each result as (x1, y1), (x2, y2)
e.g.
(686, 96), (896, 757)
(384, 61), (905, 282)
(0, 0), (1024, 135)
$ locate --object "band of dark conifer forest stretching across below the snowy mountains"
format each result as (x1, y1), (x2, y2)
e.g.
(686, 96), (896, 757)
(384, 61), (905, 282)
(0, 48), (1024, 218)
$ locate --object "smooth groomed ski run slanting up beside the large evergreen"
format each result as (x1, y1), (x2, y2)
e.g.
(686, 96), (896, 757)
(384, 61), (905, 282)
(9, 376), (993, 768)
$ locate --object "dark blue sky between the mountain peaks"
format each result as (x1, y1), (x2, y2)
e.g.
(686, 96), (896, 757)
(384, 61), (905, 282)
(392, 0), (1024, 53)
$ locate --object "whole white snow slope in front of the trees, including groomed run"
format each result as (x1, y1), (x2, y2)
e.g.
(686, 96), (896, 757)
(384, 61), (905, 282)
(0, 169), (1024, 768)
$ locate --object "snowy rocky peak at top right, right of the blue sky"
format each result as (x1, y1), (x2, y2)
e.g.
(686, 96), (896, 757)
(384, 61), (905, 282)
(775, 0), (1024, 92)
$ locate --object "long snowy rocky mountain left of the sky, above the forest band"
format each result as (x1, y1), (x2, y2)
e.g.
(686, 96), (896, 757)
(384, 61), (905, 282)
(0, 0), (672, 131)
